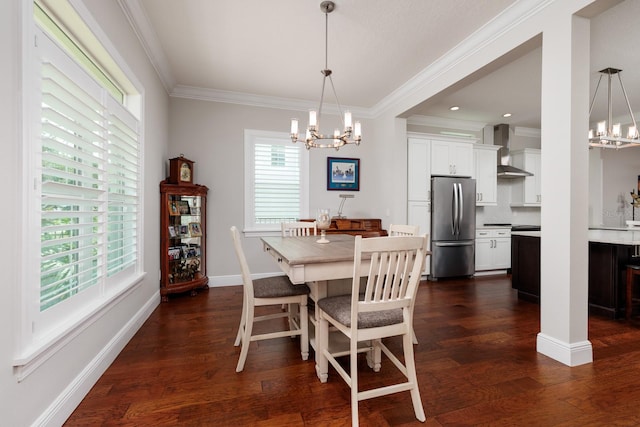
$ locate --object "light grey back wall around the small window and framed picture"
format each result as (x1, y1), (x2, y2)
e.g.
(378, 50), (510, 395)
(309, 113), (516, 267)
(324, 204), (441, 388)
(169, 98), (398, 286)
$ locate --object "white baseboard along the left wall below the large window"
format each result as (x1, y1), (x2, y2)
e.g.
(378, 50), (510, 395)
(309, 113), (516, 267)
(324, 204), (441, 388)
(32, 289), (160, 426)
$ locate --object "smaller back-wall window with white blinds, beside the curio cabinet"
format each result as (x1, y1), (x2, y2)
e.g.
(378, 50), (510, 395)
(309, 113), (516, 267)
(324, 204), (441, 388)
(245, 130), (309, 237)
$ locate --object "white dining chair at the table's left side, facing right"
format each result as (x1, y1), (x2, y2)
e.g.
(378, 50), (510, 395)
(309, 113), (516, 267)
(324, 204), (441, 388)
(231, 226), (309, 372)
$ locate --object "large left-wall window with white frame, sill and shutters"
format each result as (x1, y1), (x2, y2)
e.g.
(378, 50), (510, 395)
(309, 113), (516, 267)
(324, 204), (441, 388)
(16, 2), (143, 377)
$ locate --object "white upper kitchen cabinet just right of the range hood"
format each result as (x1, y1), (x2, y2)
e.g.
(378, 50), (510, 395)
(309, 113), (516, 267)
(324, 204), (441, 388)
(511, 148), (542, 207)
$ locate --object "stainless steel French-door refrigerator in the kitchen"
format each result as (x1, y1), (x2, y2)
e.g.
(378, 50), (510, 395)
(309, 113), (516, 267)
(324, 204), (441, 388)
(430, 176), (476, 280)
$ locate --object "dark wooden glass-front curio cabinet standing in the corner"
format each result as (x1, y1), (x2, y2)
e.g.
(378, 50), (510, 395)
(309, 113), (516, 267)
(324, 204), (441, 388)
(160, 181), (209, 302)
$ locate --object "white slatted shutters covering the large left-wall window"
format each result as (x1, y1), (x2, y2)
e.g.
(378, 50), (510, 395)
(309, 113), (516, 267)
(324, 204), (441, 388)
(40, 29), (140, 311)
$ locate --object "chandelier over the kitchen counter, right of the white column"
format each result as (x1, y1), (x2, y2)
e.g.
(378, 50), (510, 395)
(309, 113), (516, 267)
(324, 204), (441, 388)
(589, 67), (640, 149)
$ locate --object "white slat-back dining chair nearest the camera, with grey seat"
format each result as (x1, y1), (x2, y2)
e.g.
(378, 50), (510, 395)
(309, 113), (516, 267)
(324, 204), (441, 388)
(316, 235), (427, 426)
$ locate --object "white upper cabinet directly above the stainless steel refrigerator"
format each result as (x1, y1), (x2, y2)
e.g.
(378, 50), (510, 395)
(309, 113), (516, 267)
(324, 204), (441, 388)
(431, 140), (473, 176)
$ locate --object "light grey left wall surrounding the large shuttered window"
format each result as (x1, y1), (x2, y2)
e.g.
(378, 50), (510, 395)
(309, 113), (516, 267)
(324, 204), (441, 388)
(0, 0), (168, 426)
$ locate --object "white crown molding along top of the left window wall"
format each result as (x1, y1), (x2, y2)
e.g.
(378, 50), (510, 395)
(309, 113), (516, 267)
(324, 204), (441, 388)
(118, 0), (176, 94)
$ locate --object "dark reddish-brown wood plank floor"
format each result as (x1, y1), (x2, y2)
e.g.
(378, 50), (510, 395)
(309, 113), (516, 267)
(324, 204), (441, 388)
(65, 276), (640, 426)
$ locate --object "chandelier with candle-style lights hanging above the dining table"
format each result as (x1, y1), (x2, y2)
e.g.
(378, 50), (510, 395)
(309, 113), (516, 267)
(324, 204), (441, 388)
(291, 1), (362, 150)
